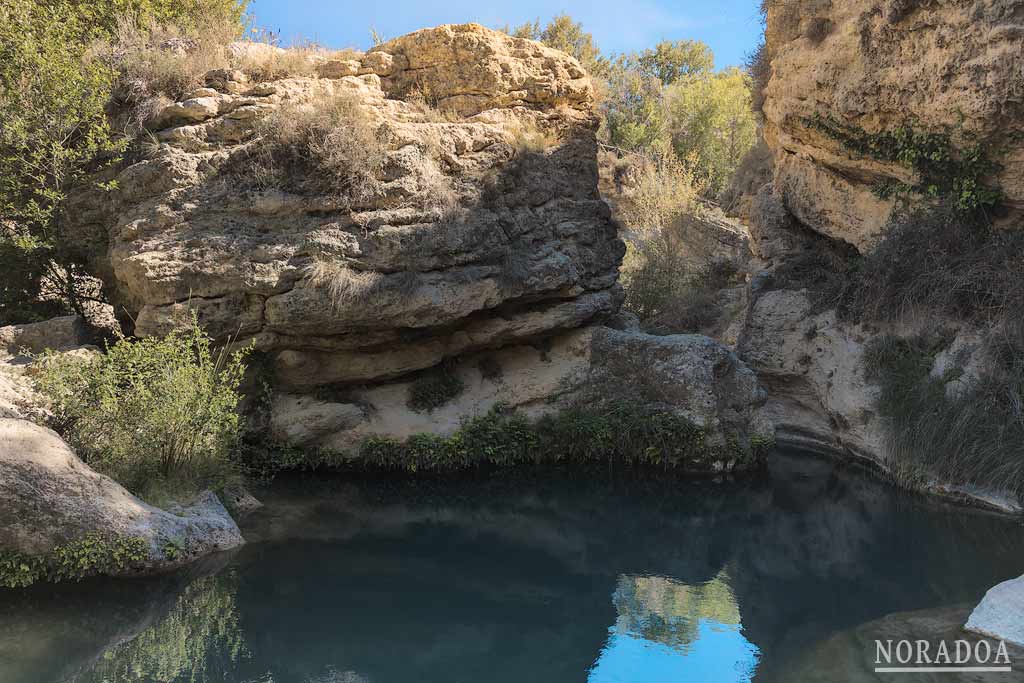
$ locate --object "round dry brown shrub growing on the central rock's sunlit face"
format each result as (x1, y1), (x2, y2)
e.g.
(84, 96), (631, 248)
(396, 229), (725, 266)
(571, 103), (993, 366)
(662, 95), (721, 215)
(239, 93), (387, 203)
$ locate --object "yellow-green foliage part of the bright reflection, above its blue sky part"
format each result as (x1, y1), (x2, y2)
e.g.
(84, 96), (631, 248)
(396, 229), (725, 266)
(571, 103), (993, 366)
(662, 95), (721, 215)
(612, 570), (739, 652)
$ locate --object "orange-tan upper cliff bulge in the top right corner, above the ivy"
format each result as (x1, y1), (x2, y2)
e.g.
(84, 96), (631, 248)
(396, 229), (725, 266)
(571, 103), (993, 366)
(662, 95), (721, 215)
(764, 0), (1024, 250)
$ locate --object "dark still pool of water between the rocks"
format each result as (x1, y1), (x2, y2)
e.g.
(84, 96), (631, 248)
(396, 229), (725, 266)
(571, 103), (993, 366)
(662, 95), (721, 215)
(0, 453), (1024, 683)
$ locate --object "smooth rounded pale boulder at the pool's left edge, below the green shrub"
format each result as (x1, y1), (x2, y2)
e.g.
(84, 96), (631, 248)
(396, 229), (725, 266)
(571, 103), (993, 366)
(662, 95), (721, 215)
(0, 418), (244, 573)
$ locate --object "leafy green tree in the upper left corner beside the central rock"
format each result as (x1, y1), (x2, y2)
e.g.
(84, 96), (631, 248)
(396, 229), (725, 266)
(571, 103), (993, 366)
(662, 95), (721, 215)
(0, 0), (246, 323)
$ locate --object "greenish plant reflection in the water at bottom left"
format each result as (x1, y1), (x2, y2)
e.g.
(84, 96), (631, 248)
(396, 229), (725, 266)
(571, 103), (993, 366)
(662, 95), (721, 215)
(81, 571), (249, 683)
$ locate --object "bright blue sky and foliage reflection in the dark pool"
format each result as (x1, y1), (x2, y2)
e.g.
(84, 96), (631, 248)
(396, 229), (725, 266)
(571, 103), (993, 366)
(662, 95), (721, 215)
(588, 572), (759, 683)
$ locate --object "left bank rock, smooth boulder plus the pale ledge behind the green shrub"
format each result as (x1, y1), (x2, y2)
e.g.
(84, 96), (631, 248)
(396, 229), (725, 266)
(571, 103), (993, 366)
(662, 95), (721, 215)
(0, 316), (244, 579)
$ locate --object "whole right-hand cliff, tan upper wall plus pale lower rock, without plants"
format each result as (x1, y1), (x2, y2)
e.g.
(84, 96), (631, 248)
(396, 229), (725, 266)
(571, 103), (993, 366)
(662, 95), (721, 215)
(738, 0), (1024, 509)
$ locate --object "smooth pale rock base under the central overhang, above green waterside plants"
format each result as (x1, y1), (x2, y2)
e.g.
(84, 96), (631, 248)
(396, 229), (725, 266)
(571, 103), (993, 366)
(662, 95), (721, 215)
(271, 327), (774, 470)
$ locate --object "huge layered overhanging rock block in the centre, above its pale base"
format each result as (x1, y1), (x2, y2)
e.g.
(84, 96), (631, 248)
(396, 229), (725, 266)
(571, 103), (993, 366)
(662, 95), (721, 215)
(82, 25), (624, 388)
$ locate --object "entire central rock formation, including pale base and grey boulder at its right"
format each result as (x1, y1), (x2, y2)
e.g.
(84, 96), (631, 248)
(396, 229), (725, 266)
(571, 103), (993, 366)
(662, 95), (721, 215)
(64, 25), (771, 451)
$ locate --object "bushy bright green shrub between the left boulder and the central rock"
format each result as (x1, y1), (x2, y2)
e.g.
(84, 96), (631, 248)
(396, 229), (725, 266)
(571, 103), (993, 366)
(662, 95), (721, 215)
(35, 318), (248, 500)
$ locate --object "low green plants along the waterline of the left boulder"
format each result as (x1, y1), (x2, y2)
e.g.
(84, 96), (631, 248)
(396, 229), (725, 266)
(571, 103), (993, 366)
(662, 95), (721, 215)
(0, 532), (148, 588)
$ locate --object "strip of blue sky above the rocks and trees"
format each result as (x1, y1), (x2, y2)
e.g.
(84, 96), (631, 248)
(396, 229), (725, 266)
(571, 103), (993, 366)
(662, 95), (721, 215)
(250, 0), (762, 67)
